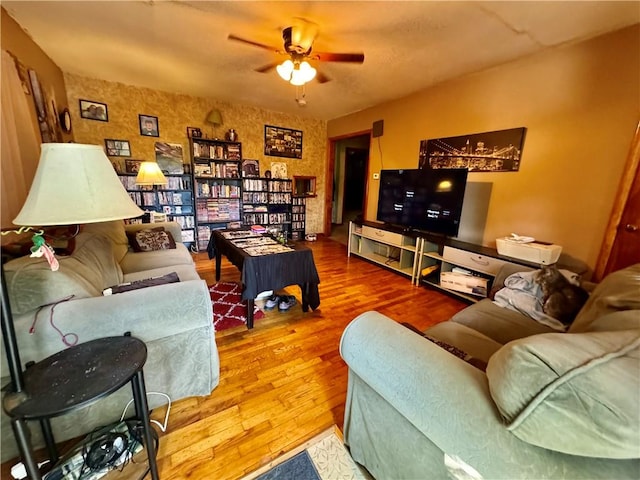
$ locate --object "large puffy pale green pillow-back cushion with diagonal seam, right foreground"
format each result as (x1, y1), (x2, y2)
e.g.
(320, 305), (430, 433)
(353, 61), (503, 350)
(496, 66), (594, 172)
(487, 330), (640, 459)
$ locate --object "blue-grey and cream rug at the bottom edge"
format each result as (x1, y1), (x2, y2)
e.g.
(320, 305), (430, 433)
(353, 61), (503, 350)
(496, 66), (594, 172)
(242, 425), (371, 480)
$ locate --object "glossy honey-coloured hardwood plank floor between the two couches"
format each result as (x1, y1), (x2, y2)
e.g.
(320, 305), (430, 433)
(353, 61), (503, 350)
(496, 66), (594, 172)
(0, 238), (466, 480)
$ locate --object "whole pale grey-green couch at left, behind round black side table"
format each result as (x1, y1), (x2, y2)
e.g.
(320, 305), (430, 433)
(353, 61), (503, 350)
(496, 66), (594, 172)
(1, 221), (220, 462)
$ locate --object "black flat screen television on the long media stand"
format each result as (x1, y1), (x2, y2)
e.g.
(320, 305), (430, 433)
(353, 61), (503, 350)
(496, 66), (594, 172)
(377, 168), (468, 237)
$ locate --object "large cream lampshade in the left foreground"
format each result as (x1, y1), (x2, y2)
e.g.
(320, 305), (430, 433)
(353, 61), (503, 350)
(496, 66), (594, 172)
(13, 143), (144, 226)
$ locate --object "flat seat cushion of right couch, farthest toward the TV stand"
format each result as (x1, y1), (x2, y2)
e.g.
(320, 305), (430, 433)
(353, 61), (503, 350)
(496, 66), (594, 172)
(451, 298), (554, 345)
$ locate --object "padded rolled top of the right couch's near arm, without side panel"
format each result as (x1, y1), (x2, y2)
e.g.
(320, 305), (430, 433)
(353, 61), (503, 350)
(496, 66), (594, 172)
(340, 312), (628, 479)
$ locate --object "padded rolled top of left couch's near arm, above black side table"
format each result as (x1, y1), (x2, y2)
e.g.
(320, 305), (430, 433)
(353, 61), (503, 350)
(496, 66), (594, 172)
(3, 280), (214, 375)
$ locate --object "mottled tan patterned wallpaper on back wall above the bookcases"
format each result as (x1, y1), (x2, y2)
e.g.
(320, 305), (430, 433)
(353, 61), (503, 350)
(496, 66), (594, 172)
(64, 74), (327, 233)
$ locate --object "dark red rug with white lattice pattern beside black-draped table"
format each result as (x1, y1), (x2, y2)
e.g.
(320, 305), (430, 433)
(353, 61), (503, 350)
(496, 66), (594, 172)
(209, 282), (264, 332)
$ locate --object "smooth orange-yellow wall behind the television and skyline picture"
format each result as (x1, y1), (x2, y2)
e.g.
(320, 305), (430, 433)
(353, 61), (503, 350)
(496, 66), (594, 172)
(327, 25), (640, 267)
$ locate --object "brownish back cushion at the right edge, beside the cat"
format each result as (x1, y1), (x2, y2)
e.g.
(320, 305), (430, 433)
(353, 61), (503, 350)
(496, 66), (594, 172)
(569, 263), (640, 333)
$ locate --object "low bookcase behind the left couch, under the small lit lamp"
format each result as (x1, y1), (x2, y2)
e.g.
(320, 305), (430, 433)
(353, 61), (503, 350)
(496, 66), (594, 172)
(118, 174), (195, 247)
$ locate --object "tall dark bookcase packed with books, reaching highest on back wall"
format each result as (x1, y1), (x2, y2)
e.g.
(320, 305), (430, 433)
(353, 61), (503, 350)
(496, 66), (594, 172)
(191, 138), (242, 251)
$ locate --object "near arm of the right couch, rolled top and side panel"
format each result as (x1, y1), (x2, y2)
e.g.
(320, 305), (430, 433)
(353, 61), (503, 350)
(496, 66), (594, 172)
(340, 312), (640, 480)
